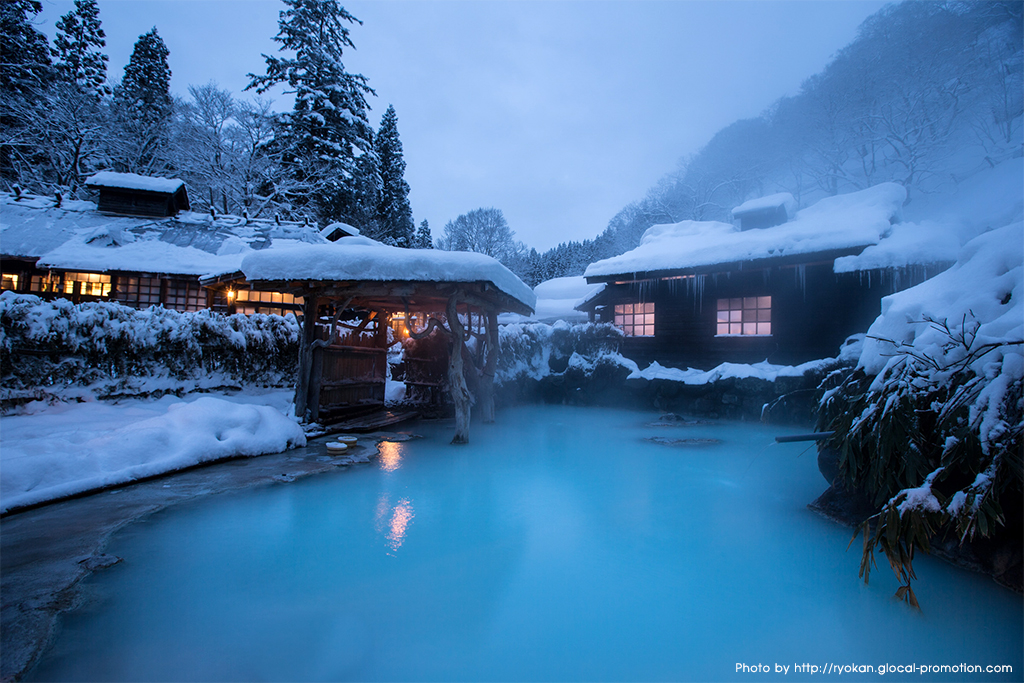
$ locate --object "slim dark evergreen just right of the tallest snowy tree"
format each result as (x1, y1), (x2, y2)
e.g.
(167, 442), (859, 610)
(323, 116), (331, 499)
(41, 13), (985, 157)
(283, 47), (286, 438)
(374, 104), (416, 247)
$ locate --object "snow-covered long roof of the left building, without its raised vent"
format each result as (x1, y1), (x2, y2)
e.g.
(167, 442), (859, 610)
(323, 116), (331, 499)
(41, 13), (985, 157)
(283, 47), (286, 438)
(0, 194), (328, 276)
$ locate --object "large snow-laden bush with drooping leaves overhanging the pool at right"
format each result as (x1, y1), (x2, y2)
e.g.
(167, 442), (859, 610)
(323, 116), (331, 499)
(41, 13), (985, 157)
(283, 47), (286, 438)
(818, 223), (1024, 604)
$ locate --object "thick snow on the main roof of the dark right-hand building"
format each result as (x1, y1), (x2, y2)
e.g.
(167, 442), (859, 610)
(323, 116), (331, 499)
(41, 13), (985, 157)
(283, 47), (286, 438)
(584, 182), (906, 278)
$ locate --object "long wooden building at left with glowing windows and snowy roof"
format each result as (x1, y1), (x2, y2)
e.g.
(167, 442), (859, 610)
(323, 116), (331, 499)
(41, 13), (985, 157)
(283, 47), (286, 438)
(0, 185), (328, 314)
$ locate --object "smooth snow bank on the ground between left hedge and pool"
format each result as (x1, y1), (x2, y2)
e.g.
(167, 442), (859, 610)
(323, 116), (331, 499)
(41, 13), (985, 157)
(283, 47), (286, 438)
(0, 391), (306, 512)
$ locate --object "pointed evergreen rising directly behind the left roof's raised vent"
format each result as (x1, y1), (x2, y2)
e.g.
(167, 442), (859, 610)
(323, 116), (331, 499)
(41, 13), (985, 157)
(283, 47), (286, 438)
(111, 27), (174, 175)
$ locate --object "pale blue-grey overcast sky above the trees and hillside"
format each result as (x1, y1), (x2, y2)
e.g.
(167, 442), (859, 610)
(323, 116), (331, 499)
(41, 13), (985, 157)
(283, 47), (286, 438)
(39, 0), (885, 251)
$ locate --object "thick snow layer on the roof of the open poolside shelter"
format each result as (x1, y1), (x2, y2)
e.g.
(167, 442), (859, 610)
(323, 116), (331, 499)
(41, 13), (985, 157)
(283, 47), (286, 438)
(242, 237), (537, 309)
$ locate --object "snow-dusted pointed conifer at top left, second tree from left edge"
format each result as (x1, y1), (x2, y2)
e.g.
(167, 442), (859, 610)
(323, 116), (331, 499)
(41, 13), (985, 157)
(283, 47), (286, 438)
(50, 0), (110, 94)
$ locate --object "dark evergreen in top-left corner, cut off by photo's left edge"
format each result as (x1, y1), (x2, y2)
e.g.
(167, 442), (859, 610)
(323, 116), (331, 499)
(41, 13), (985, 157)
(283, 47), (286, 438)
(0, 0), (53, 94)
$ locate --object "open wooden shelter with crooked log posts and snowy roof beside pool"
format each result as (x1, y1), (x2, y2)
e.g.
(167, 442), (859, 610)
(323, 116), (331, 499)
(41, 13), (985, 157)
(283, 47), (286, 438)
(242, 237), (536, 443)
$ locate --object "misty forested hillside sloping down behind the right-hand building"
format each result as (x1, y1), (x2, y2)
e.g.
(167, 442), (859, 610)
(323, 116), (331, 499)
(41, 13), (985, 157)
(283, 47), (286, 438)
(520, 0), (1024, 283)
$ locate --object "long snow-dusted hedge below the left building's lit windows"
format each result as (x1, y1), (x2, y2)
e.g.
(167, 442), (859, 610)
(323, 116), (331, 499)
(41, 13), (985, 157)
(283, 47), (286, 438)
(0, 292), (299, 400)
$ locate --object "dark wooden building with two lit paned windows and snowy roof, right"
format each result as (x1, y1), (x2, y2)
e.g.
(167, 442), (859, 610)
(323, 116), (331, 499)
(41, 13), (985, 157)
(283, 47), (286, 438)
(578, 183), (956, 370)
